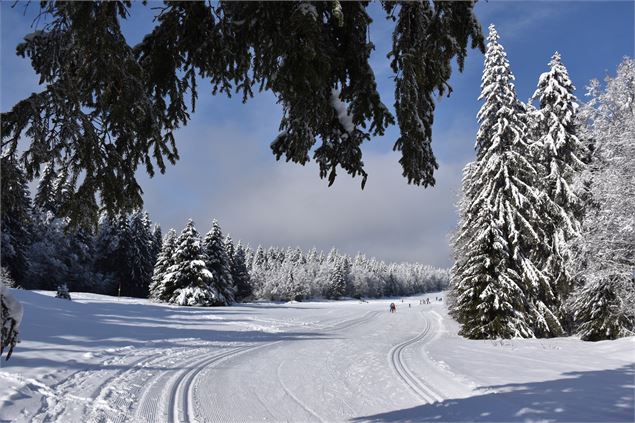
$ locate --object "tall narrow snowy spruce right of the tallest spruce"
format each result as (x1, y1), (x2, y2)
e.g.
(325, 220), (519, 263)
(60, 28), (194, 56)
(532, 52), (587, 321)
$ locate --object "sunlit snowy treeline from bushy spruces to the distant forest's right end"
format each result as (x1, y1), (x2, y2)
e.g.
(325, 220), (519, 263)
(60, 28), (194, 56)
(150, 220), (449, 306)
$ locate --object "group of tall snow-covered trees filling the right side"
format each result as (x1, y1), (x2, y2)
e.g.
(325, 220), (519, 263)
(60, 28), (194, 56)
(450, 25), (635, 339)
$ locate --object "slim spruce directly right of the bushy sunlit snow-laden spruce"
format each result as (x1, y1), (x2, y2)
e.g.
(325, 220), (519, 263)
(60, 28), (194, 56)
(203, 219), (236, 305)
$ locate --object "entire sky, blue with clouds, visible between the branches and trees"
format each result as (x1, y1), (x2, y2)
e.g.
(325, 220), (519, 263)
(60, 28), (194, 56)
(0, 1), (635, 266)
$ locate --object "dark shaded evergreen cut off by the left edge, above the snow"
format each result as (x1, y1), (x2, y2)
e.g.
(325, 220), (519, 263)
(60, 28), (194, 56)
(0, 154), (31, 285)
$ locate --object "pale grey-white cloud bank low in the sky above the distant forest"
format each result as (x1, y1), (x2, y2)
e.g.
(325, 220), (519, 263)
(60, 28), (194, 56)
(142, 117), (462, 266)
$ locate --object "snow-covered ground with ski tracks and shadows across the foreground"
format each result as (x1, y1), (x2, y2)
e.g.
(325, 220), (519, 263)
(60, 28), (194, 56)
(0, 290), (635, 423)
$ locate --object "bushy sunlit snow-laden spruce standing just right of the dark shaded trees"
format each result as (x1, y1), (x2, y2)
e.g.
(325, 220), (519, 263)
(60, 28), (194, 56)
(154, 219), (222, 306)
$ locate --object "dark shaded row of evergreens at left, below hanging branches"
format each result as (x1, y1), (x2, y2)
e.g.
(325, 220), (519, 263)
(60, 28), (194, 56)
(0, 160), (162, 297)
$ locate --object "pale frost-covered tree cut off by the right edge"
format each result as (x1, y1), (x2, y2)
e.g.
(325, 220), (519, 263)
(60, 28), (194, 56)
(569, 58), (635, 341)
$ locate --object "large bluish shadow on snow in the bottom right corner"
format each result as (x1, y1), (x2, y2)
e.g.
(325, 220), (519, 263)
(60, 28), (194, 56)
(351, 365), (635, 422)
